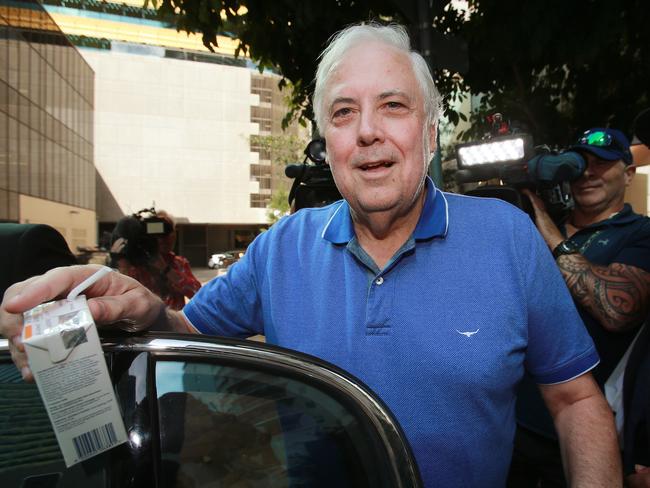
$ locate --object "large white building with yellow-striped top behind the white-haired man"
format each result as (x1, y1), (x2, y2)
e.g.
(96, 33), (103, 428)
(45, 0), (302, 266)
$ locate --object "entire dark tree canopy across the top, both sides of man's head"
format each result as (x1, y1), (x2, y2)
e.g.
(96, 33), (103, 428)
(148, 0), (650, 145)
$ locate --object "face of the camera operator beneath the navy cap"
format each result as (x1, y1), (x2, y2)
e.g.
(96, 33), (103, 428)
(571, 152), (634, 212)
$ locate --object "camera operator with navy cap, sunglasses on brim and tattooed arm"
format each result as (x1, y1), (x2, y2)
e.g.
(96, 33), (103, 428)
(509, 128), (650, 486)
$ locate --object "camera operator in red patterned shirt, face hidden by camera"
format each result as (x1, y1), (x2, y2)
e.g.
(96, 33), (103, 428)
(111, 210), (201, 310)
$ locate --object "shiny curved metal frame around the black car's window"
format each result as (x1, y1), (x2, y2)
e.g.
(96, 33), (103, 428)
(104, 332), (422, 488)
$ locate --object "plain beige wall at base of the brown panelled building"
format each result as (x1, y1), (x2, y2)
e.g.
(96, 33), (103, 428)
(19, 195), (97, 253)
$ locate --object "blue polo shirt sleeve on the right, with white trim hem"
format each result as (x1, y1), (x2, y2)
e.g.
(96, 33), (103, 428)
(518, 215), (599, 384)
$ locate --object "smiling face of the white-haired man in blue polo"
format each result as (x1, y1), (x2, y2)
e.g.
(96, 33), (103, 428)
(324, 42), (435, 221)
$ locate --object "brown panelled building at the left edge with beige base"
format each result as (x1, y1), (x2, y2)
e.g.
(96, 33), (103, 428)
(0, 0), (97, 251)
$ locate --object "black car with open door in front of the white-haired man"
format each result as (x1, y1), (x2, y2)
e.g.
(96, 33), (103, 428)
(0, 333), (422, 488)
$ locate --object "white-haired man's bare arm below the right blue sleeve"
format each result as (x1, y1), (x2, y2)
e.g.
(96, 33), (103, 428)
(540, 373), (623, 488)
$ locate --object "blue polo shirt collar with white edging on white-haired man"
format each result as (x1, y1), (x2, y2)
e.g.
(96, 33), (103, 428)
(321, 176), (449, 244)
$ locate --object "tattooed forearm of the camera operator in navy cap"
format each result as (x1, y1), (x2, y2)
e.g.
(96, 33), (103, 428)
(557, 254), (650, 332)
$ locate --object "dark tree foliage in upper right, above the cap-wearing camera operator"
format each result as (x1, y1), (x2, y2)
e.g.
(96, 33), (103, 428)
(460, 0), (650, 146)
